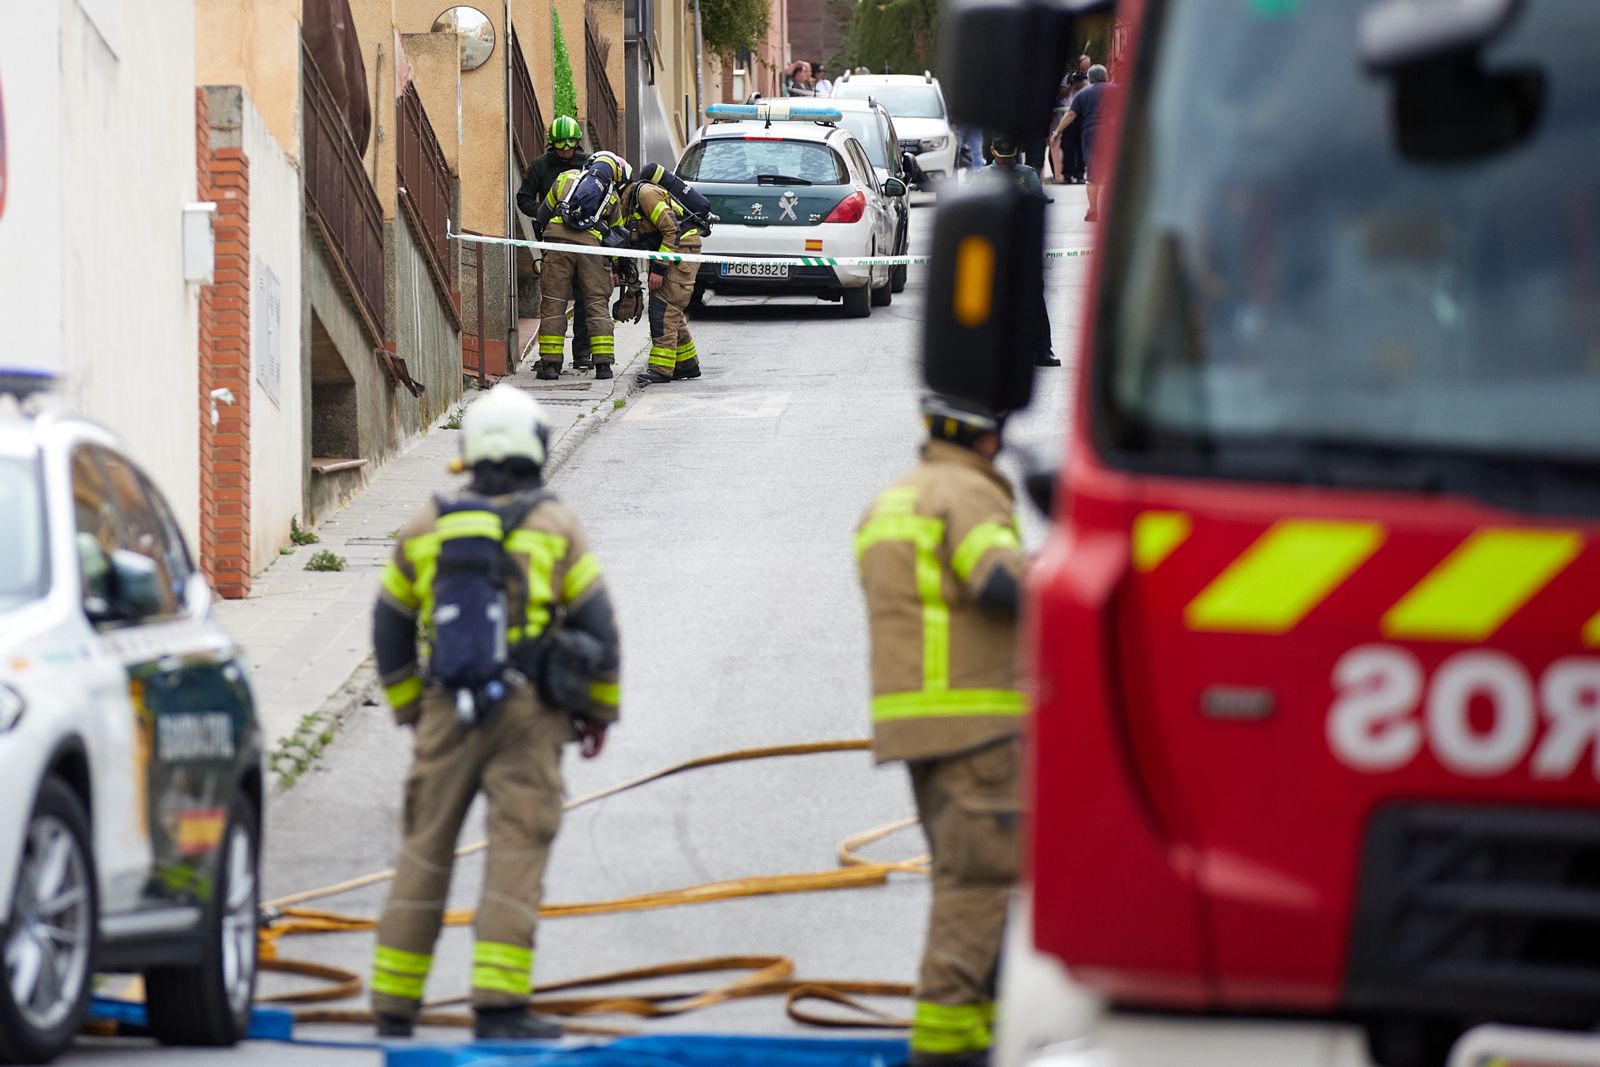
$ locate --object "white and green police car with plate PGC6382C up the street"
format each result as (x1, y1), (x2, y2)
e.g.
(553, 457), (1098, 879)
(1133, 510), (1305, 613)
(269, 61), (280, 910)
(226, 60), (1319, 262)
(677, 101), (907, 318)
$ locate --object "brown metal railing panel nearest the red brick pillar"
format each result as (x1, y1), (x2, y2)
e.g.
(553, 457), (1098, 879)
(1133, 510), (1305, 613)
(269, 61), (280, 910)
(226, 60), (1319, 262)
(301, 42), (384, 344)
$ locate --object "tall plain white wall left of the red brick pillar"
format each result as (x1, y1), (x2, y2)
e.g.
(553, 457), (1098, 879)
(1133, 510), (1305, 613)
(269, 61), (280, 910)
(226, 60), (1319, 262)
(47, 0), (200, 542)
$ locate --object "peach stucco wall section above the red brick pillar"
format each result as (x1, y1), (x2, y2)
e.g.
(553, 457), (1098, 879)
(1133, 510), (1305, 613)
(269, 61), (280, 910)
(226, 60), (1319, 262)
(195, 0), (301, 162)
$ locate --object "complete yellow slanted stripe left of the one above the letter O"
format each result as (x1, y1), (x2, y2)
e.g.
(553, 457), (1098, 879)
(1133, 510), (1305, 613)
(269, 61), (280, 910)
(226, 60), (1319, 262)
(1184, 518), (1384, 633)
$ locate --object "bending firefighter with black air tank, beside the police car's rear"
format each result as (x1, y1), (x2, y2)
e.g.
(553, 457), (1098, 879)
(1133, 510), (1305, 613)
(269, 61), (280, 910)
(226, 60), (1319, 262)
(622, 163), (706, 386)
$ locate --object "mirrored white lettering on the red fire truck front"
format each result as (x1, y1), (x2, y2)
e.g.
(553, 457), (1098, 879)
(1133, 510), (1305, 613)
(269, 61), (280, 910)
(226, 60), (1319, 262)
(1326, 645), (1600, 781)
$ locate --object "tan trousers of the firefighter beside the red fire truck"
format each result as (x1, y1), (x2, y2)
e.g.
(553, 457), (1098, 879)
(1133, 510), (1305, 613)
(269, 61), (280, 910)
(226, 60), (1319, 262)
(909, 737), (1019, 1064)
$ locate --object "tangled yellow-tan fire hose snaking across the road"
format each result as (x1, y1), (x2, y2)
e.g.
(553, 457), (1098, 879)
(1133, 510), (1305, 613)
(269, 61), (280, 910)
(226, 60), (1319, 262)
(258, 739), (930, 1035)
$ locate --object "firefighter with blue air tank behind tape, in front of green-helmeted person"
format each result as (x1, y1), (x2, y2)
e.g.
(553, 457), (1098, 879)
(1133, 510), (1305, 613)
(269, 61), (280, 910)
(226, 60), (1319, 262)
(534, 152), (627, 381)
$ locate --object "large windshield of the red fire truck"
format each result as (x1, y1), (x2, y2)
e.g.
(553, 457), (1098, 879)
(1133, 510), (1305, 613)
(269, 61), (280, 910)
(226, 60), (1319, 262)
(1094, 0), (1600, 491)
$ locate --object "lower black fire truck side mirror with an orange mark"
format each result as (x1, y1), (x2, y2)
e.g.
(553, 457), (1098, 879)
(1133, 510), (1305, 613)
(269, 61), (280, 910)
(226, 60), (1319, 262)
(922, 182), (1045, 411)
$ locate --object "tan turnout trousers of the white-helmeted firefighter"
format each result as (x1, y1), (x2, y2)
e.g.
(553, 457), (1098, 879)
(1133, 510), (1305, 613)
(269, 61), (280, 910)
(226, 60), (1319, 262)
(373, 689), (573, 1017)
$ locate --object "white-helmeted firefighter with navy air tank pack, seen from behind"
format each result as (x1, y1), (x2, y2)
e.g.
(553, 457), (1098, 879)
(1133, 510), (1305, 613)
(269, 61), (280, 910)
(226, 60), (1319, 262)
(371, 384), (621, 1038)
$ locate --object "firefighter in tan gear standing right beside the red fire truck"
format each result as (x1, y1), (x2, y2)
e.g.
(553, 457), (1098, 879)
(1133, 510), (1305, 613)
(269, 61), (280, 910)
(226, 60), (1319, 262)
(856, 397), (1024, 1065)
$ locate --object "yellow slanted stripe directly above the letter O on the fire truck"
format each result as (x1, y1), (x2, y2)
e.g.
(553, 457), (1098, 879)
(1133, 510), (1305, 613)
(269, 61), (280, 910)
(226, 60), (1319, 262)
(1382, 530), (1584, 641)
